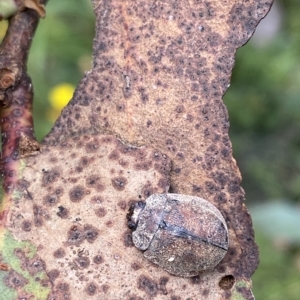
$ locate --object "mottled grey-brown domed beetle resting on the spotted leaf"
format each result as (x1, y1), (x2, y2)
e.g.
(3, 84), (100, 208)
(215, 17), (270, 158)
(128, 194), (228, 277)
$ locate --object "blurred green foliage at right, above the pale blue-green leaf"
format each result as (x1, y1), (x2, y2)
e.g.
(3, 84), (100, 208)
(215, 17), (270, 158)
(224, 1), (300, 202)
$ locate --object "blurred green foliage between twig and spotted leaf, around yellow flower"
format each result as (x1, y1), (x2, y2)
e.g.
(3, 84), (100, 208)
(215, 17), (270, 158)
(28, 0), (95, 140)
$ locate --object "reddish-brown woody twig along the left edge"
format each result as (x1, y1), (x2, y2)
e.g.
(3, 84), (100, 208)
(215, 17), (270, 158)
(0, 1), (46, 226)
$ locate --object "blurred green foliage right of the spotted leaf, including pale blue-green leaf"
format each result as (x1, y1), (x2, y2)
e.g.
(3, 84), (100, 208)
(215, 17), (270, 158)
(224, 0), (300, 300)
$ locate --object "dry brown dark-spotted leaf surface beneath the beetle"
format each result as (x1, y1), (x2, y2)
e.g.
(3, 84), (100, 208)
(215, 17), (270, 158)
(1, 0), (272, 300)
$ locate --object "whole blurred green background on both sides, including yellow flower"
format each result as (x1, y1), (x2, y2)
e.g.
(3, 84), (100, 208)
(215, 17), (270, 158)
(0, 0), (300, 300)
